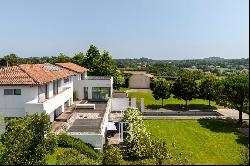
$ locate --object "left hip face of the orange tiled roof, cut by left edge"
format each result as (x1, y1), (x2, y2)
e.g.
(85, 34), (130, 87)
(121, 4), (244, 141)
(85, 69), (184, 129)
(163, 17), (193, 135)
(0, 66), (36, 85)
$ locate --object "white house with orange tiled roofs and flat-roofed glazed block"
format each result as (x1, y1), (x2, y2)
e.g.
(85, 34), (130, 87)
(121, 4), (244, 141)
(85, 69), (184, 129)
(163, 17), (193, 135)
(0, 63), (113, 121)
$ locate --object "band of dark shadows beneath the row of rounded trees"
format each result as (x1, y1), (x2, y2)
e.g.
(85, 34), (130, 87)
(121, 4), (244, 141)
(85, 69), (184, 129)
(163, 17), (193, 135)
(146, 104), (217, 111)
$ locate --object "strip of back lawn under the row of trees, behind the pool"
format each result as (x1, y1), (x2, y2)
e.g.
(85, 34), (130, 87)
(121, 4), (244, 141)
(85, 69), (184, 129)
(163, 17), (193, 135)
(128, 92), (223, 110)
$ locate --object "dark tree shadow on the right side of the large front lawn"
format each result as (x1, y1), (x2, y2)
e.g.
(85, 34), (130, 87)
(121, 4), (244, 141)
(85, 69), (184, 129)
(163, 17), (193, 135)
(198, 119), (249, 146)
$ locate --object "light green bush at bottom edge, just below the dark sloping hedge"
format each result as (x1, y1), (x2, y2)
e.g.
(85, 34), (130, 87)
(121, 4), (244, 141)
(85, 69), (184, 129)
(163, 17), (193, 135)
(56, 148), (99, 165)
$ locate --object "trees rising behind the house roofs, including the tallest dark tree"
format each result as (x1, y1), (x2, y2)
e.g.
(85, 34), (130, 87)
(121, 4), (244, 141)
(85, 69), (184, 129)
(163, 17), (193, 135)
(0, 45), (125, 89)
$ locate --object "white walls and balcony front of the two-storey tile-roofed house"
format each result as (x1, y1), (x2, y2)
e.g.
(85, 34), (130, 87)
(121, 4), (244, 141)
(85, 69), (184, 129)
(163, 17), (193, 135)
(0, 78), (73, 121)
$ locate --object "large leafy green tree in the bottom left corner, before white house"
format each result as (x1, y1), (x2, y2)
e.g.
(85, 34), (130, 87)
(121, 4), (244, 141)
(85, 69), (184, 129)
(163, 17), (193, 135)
(1, 113), (56, 165)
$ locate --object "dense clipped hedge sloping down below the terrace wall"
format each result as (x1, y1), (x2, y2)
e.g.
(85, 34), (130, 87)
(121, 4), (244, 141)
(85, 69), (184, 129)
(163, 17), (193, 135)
(58, 134), (100, 159)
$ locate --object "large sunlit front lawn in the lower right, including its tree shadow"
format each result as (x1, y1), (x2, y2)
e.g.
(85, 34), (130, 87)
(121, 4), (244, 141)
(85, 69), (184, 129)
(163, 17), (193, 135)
(145, 120), (249, 165)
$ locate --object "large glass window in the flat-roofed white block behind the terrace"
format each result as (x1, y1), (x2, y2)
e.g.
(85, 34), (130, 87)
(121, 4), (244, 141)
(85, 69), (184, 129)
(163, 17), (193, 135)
(92, 87), (110, 100)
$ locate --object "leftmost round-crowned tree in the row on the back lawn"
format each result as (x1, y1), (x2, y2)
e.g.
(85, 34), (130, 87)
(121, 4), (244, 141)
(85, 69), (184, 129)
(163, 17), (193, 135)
(152, 78), (171, 107)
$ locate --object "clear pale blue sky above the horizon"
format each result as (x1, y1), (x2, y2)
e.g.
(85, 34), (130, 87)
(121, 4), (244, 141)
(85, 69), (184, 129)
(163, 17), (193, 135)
(0, 0), (249, 60)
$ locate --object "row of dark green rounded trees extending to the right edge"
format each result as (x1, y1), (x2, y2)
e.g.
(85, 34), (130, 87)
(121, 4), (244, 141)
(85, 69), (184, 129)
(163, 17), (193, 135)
(151, 71), (249, 124)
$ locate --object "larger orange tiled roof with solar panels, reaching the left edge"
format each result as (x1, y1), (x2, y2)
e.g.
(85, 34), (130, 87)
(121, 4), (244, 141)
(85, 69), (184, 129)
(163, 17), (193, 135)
(0, 64), (76, 85)
